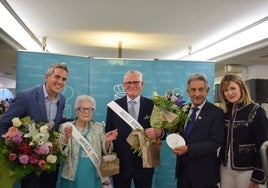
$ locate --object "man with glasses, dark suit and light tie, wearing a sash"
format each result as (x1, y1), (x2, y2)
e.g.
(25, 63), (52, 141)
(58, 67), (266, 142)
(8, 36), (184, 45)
(105, 70), (164, 188)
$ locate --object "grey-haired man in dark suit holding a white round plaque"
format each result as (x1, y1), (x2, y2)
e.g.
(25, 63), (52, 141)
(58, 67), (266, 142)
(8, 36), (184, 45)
(173, 74), (224, 188)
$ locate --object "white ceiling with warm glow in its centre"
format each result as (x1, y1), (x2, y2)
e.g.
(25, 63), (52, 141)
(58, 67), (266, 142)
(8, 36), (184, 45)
(0, 0), (268, 83)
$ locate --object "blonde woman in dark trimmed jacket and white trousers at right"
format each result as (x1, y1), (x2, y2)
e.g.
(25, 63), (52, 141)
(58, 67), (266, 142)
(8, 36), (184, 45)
(220, 74), (268, 188)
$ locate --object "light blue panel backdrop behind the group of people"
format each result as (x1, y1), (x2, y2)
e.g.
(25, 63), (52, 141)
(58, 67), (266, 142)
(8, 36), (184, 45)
(16, 51), (215, 188)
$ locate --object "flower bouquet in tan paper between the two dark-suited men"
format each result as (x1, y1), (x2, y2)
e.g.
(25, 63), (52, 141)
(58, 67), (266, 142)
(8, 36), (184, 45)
(150, 90), (190, 134)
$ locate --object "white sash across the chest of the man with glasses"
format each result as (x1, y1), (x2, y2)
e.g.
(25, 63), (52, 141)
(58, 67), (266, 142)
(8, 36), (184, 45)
(107, 101), (144, 130)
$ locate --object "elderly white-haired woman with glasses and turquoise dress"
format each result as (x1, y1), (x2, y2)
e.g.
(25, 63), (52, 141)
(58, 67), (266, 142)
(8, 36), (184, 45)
(58, 95), (118, 188)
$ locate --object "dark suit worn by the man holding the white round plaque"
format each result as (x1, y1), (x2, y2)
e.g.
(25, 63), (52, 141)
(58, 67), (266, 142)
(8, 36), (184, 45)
(176, 102), (224, 187)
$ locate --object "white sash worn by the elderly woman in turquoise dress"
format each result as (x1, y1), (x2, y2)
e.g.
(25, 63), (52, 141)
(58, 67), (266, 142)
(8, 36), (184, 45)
(63, 122), (112, 188)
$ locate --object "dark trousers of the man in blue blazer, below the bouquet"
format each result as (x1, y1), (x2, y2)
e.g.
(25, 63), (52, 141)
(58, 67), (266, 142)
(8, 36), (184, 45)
(21, 170), (58, 188)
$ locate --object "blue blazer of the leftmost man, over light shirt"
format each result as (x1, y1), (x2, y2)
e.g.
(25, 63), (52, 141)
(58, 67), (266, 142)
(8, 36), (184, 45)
(0, 85), (65, 135)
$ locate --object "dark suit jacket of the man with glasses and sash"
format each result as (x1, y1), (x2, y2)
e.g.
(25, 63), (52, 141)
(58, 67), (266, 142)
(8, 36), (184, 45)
(105, 96), (154, 177)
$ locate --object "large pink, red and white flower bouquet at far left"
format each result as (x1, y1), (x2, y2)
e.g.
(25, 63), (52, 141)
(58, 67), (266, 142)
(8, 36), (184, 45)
(0, 117), (63, 188)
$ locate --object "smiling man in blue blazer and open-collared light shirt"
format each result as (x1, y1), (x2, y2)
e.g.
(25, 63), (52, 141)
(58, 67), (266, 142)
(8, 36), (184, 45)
(0, 63), (68, 188)
